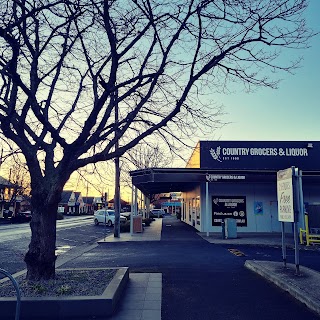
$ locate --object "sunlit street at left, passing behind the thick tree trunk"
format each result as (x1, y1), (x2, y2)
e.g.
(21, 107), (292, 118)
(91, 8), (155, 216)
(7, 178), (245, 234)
(0, 216), (113, 278)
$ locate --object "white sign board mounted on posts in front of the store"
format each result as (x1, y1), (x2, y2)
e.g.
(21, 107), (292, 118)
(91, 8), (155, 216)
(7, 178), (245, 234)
(277, 168), (294, 222)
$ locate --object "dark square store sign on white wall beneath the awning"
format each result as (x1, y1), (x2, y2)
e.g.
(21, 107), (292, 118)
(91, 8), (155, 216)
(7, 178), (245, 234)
(212, 196), (247, 227)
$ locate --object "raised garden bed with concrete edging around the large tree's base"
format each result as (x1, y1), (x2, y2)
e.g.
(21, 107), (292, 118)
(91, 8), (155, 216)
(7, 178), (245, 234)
(0, 268), (129, 320)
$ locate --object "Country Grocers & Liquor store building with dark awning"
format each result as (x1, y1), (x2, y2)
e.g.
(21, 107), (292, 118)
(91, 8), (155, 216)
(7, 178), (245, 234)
(131, 141), (320, 233)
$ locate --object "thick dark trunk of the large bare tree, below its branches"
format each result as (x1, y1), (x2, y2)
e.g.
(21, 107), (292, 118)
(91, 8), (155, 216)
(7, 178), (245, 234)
(24, 193), (61, 280)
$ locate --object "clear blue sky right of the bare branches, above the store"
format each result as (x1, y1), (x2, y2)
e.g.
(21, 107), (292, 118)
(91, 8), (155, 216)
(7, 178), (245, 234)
(214, 0), (320, 141)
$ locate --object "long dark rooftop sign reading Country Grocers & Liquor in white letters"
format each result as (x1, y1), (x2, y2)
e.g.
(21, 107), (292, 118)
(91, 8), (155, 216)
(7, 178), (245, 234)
(200, 141), (320, 170)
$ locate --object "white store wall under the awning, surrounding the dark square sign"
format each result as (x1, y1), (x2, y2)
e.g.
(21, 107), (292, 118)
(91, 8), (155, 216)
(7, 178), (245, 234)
(182, 182), (320, 233)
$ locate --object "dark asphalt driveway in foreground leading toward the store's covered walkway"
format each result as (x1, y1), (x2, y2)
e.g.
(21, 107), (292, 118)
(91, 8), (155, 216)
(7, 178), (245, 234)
(60, 217), (319, 320)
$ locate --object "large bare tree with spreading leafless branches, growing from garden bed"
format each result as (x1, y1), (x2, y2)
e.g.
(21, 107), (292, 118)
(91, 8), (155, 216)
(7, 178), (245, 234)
(0, 0), (312, 279)
